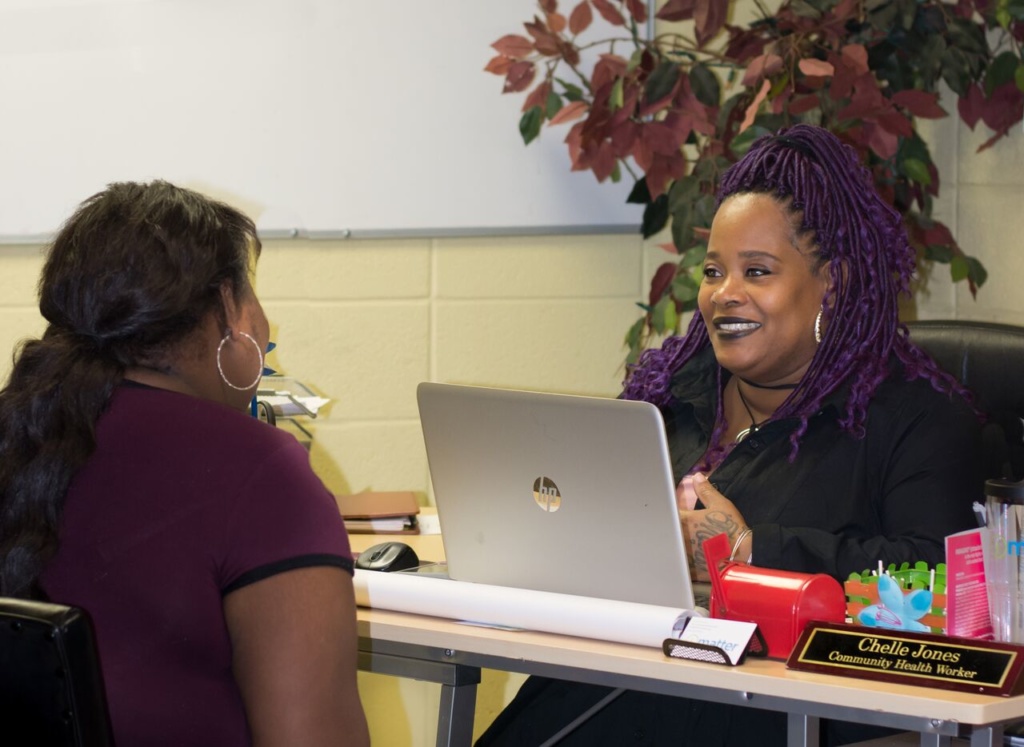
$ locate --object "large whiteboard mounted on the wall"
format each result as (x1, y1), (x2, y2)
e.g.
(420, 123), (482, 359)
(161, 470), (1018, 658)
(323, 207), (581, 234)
(0, 0), (642, 241)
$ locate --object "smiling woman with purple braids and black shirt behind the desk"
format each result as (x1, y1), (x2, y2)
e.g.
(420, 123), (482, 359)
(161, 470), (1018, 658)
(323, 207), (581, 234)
(478, 125), (984, 747)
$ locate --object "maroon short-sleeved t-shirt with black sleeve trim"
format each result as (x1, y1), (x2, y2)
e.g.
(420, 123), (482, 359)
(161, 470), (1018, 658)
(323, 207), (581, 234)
(42, 384), (352, 747)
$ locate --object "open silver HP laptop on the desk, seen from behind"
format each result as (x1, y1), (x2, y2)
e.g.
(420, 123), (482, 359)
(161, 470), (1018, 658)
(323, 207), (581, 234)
(417, 383), (694, 610)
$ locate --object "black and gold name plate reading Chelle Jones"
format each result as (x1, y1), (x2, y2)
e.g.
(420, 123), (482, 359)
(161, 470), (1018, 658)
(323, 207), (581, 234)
(785, 622), (1024, 696)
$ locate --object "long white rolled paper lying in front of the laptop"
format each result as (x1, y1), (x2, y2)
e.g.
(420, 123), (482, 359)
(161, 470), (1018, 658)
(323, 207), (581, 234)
(355, 570), (694, 648)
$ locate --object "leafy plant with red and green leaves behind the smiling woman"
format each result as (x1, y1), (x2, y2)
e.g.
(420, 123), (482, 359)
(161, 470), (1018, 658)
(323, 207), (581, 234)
(486, 0), (1024, 362)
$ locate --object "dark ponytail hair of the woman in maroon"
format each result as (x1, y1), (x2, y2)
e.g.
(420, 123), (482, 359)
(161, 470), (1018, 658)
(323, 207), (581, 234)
(0, 181), (259, 597)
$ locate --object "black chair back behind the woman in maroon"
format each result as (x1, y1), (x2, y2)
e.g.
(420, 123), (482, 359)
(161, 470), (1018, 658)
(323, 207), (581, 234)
(0, 597), (114, 747)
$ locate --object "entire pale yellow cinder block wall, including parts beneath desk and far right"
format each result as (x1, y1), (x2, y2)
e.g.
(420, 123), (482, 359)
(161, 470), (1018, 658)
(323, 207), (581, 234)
(0, 94), (1024, 746)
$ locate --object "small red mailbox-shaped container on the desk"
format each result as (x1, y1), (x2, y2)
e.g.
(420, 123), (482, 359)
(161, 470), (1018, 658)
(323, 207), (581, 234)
(703, 534), (846, 659)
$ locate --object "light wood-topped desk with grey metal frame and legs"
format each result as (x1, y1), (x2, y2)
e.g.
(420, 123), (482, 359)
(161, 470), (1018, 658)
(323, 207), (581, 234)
(353, 536), (1024, 747)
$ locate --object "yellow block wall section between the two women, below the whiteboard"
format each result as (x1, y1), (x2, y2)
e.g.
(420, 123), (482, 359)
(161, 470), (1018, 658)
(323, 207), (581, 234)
(257, 235), (644, 502)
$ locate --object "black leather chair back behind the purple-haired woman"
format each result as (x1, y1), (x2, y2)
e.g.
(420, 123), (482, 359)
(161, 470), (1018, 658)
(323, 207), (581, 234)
(906, 321), (1024, 481)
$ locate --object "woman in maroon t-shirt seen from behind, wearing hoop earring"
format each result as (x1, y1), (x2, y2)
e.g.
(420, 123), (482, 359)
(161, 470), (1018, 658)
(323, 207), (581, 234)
(0, 181), (369, 747)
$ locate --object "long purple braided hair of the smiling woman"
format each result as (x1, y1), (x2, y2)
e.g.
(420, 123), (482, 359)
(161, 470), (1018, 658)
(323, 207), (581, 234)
(623, 124), (970, 467)
